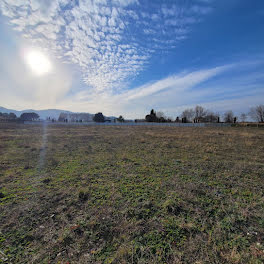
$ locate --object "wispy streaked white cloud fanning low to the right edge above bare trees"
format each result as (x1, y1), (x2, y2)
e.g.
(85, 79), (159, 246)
(54, 61), (264, 118)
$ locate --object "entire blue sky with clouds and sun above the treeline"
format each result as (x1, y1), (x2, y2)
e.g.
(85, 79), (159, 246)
(0, 0), (264, 118)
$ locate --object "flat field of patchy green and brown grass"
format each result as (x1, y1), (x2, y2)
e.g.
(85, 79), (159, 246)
(0, 124), (264, 264)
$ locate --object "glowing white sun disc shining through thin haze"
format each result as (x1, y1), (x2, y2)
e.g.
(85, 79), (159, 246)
(25, 50), (52, 75)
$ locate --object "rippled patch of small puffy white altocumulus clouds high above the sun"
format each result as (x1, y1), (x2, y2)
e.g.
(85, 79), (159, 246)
(0, 0), (212, 95)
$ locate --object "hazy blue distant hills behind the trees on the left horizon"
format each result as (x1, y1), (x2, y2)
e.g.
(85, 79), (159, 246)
(0, 106), (115, 119)
